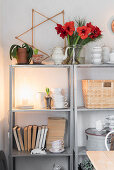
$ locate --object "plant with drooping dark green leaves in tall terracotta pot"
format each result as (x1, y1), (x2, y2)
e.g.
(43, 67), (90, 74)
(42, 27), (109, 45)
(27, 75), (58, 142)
(10, 43), (33, 64)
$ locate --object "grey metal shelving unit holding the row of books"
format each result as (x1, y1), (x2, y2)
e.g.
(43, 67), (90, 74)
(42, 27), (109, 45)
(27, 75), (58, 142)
(9, 65), (74, 170)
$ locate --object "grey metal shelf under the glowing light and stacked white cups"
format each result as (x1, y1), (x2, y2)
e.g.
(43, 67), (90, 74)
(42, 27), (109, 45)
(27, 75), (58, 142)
(12, 108), (71, 112)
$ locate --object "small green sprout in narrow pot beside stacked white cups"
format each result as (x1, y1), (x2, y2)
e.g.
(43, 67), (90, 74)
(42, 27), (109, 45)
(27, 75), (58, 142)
(45, 88), (52, 109)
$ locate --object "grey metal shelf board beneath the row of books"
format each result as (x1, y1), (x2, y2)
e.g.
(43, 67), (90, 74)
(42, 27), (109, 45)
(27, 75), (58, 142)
(10, 148), (72, 157)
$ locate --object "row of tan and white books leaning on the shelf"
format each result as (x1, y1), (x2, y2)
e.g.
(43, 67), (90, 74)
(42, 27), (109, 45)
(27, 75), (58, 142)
(13, 125), (48, 152)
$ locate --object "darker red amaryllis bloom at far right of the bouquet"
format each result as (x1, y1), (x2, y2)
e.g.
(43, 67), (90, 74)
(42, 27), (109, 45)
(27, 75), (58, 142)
(89, 26), (101, 39)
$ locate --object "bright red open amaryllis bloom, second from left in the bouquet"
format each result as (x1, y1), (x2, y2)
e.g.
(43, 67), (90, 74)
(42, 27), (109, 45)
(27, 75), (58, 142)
(63, 21), (75, 36)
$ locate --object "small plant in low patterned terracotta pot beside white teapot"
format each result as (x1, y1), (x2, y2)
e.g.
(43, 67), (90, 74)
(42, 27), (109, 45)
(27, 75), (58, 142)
(32, 48), (43, 64)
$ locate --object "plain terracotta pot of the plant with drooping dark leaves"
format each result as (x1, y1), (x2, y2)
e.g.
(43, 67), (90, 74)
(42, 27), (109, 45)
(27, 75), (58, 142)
(17, 48), (28, 64)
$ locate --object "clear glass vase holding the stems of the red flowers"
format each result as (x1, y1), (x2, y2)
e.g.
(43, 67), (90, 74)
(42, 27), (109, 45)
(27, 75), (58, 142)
(63, 45), (85, 64)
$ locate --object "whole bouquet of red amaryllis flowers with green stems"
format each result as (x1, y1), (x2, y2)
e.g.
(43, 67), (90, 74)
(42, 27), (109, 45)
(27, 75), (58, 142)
(55, 20), (102, 64)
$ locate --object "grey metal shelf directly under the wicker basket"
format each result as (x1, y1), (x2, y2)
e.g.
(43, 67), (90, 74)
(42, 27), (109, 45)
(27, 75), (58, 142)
(77, 106), (114, 112)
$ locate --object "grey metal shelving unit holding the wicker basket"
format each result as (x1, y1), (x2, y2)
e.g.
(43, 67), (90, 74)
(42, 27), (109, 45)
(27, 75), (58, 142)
(73, 64), (114, 170)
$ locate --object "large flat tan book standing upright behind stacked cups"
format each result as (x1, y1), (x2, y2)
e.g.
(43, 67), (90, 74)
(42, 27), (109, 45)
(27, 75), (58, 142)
(46, 117), (66, 150)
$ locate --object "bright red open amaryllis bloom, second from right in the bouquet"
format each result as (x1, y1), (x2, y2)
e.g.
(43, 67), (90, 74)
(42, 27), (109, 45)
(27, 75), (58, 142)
(77, 26), (91, 39)
